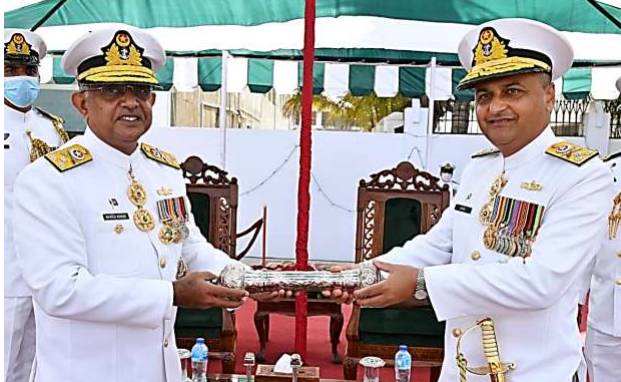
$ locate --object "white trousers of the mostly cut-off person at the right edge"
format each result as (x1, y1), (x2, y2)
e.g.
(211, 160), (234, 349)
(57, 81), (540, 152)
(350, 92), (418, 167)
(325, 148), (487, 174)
(585, 326), (621, 382)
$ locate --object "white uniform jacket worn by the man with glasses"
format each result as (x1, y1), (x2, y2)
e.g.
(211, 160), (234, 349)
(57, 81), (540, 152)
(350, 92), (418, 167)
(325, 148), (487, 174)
(15, 129), (233, 382)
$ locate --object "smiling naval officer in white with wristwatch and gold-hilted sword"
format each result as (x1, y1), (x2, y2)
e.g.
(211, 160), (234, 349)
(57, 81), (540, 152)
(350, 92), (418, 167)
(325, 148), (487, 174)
(326, 19), (612, 382)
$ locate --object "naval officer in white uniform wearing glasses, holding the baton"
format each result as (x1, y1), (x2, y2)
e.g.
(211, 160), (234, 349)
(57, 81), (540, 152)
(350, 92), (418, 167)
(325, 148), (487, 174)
(15, 27), (254, 382)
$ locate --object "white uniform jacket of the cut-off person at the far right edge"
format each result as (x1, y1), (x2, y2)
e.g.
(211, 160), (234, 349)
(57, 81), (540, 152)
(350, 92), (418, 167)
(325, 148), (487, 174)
(588, 157), (621, 338)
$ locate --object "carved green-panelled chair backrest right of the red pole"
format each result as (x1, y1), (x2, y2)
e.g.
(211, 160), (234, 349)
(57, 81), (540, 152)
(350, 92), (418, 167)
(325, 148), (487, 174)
(356, 162), (450, 263)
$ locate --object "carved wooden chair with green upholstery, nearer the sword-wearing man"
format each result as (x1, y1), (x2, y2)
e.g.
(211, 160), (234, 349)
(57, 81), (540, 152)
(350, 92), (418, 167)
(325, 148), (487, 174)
(343, 162), (450, 381)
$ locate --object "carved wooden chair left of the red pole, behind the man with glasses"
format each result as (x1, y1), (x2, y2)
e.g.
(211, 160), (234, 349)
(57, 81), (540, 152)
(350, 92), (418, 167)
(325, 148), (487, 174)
(175, 156), (263, 374)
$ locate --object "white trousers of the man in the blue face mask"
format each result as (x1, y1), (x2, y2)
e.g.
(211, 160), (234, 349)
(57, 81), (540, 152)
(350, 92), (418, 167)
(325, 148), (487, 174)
(4, 297), (35, 382)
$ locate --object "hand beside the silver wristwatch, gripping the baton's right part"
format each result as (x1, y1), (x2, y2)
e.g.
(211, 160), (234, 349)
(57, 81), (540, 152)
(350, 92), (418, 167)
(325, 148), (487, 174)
(354, 261), (418, 308)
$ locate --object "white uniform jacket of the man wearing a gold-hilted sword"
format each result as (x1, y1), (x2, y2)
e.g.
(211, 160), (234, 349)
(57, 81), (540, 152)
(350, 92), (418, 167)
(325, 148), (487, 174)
(378, 128), (612, 382)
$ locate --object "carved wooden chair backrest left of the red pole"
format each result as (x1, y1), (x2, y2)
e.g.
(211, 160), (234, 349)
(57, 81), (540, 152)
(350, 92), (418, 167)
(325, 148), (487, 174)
(181, 156), (239, 257)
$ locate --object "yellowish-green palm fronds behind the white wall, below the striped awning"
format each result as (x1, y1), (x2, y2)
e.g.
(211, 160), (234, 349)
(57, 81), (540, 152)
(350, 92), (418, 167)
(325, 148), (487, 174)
(283, 92), (411, 131)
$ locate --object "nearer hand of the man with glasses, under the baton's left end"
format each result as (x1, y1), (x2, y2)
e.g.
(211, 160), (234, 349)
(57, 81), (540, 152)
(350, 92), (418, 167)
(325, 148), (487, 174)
(173, 272), (248, 309)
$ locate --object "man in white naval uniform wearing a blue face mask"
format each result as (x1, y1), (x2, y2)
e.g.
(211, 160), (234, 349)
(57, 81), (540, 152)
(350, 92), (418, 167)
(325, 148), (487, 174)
(4, 29), (69, 382)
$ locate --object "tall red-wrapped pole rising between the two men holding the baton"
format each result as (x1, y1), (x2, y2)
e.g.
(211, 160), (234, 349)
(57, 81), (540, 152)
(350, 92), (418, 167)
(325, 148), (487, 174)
(295, 0), (315, 359)
